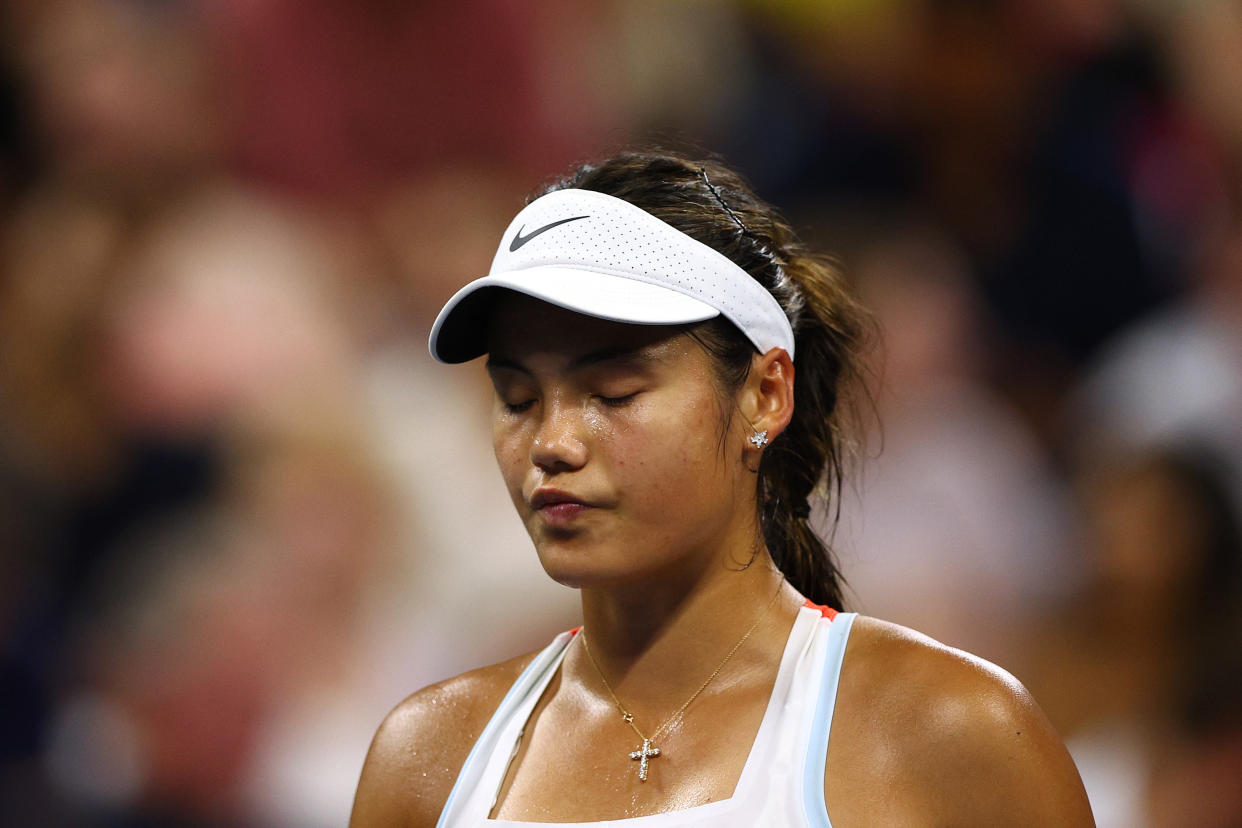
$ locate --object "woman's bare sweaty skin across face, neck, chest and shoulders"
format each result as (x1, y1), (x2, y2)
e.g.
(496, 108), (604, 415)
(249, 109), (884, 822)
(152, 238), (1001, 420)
(350, 297), (1093, 828)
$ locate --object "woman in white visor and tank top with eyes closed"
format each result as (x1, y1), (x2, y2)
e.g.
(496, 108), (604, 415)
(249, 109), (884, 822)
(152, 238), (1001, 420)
(353, 154), (1092, 828)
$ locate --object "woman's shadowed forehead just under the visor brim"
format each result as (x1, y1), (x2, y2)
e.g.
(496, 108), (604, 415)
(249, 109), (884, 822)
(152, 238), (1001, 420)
(487, 292), (689, 361)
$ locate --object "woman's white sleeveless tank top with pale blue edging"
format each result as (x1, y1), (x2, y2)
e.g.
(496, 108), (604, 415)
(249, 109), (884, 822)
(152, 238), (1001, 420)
(437, 602), (856, 828)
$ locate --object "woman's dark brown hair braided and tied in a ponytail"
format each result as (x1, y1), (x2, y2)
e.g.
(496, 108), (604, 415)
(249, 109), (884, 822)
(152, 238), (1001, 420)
(544, 151), (869, 610)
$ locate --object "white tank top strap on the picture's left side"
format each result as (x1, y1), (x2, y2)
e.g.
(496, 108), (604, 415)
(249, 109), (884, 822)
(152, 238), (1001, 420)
(436, 627), (581, 828)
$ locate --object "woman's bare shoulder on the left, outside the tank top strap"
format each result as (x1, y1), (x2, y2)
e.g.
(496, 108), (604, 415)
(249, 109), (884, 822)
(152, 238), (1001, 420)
(349, 653), (535, 828)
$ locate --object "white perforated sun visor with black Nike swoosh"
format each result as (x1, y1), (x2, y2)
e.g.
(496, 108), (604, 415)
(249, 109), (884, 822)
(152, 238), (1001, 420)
(428, 190), (794, 362)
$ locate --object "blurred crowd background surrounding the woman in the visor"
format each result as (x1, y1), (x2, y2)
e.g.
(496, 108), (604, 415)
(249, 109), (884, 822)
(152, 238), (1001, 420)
(0, 0), (1242, 828)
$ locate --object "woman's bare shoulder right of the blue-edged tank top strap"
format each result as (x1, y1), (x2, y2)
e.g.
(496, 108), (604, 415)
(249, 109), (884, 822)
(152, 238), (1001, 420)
(825, 617), (1094, 826)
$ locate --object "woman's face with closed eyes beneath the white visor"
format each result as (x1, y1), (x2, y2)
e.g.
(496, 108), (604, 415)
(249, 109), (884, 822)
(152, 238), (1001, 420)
(488, 295), (755, 587)
